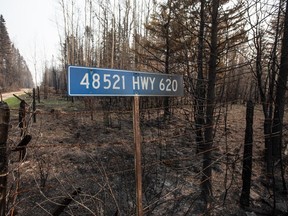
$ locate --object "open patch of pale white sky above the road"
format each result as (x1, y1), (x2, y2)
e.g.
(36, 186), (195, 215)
(0, 0), (62, 85)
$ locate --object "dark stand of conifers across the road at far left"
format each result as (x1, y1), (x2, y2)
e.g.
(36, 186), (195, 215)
(0, 15), (33, 91)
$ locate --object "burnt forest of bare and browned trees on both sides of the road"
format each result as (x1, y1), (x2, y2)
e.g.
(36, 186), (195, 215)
(0, 0), (288, 215)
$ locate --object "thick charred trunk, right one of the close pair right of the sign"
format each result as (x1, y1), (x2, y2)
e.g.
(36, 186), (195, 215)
(201, 0), (220, 208)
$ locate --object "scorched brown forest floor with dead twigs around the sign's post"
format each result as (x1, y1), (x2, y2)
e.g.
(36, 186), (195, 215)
(4, 95), (288, 216)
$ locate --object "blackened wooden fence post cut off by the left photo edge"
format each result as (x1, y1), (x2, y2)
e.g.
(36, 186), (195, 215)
(0, 101), (10, 216)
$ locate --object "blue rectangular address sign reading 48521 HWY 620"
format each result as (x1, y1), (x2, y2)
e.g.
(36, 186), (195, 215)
(68, 66), (183, 96)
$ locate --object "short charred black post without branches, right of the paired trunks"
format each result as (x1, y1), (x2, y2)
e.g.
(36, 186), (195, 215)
(240, 101), (254, 208)
